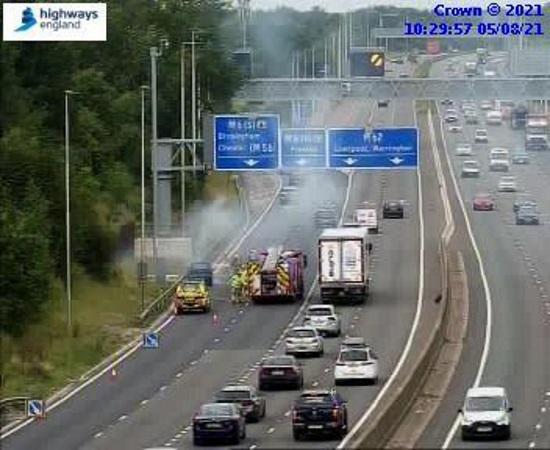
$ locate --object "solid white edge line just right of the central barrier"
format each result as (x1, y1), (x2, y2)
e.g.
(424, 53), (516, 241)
(440, 104), (493, 449)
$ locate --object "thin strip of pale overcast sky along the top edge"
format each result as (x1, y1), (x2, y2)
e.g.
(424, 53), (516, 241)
(250, 0), (498, 12)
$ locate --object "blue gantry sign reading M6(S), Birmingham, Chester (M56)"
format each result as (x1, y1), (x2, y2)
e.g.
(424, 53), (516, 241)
(214, 114), (279, 170)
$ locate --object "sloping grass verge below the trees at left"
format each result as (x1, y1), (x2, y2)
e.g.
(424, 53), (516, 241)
(1, 173), (238, 398)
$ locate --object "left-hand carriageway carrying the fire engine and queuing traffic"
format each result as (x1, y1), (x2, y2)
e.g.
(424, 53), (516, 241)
(2, 62), (435, 450)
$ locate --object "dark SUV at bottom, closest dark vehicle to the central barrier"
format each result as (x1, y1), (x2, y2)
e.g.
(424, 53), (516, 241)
(292, 389), (348, 441)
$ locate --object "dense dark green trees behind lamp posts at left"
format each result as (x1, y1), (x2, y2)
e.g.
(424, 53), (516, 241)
(0, 0), (240, 334)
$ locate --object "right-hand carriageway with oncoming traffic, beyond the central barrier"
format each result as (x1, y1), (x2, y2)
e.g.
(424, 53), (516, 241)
(418, 53), (550, 448)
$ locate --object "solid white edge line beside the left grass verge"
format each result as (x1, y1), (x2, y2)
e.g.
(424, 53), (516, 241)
(0, 177), (283, 440)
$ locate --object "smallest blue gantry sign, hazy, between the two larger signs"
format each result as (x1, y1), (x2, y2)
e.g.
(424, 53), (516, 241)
(281, 128), (327, 169)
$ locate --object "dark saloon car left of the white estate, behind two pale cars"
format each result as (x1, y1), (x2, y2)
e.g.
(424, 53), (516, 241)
(258, 355), (304, 391)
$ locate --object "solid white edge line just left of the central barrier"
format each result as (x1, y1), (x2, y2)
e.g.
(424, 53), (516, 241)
(336, 100), (430, 449)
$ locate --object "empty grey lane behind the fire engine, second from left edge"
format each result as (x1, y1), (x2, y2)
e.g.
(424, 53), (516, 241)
(68, 98), (370, 449)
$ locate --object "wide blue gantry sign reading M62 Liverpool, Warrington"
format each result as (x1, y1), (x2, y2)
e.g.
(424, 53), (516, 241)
(328, 128), (418, 169)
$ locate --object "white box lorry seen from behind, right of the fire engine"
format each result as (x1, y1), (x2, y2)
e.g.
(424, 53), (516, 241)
(318, 227), (372, 303)
